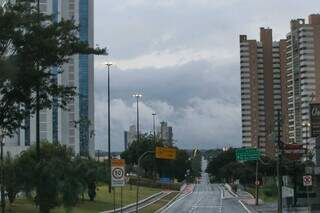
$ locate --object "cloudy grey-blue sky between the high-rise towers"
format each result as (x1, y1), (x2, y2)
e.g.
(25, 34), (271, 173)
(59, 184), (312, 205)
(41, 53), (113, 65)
(95, 0), (320, 151)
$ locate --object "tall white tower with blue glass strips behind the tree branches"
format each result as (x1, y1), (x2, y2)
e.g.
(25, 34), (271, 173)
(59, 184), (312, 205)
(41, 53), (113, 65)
(2, 0), (95, 156)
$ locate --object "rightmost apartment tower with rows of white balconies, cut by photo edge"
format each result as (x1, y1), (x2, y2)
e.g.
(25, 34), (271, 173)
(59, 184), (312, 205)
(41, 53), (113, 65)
(286, 14), (320, 143)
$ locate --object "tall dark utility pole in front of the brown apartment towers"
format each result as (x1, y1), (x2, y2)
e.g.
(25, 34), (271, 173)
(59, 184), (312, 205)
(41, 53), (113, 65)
(277, 109), (282, 213)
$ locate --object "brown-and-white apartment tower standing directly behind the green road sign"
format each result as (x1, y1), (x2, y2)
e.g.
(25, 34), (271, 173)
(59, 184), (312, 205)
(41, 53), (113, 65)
(240, 28), (286, 155)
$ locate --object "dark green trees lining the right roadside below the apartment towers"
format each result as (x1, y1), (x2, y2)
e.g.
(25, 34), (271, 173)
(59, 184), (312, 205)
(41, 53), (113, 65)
(206, 148), (305, 201)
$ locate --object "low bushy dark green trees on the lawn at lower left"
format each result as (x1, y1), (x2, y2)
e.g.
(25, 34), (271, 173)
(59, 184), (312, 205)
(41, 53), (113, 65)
(4, 142), (103, 213)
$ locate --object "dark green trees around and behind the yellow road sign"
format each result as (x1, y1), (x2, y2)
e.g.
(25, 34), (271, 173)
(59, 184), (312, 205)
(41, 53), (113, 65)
(121, 134), (201, 187)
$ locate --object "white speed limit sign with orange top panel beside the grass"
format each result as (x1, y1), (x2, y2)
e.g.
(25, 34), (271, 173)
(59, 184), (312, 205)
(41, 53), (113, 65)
(111, 159), (125, 187)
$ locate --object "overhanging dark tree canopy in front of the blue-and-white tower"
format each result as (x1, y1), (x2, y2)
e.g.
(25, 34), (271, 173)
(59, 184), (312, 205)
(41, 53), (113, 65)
(0, 0), (105, 139)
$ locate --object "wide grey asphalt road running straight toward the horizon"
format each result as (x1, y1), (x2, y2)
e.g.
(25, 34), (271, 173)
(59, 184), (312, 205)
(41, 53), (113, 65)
(163, 160), (249, 213)
